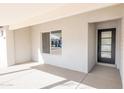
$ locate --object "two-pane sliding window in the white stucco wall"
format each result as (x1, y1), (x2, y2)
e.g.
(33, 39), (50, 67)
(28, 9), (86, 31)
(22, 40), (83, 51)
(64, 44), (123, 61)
(42, 30), (62, 55)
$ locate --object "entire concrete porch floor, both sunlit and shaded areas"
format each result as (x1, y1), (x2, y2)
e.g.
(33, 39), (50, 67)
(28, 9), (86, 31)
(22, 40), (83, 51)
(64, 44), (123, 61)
(0, 62), (122, 89)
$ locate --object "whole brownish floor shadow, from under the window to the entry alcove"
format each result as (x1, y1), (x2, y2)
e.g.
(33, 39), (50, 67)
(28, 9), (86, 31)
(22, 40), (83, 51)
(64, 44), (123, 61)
(32, 64), (122, 89)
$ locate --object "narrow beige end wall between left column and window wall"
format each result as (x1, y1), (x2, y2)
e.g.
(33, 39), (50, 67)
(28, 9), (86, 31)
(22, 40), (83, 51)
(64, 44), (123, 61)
(14, 27), (32, 63)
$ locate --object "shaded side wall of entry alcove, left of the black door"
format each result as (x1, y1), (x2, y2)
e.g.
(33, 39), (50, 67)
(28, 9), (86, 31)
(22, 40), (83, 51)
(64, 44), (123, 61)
(88, 23), (97, 72)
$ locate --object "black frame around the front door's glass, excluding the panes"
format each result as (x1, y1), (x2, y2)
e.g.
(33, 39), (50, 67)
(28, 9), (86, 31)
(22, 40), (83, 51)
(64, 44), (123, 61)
(96, 28), (116, 65)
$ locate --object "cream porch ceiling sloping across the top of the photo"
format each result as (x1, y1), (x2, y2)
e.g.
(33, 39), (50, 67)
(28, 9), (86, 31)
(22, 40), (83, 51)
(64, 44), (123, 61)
(0, 3), (115, 29)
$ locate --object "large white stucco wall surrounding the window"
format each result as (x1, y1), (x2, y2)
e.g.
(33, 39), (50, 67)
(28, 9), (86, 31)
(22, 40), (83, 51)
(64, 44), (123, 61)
(32, 15), (87, 72)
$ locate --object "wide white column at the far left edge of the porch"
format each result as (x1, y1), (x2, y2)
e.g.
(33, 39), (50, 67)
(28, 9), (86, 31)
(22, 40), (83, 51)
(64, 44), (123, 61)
(0, 26), (15, 68)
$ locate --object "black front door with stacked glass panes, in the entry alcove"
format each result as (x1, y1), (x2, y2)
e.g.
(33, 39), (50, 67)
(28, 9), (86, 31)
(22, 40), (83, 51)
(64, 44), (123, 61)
(97, 28), (116, 64)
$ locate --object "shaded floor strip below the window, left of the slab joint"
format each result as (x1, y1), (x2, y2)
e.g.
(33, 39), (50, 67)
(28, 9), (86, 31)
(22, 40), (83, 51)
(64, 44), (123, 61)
(31, 64), (85, 82)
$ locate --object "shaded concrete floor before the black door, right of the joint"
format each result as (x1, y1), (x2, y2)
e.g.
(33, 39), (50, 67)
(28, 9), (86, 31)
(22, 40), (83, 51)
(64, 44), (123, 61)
(79, 65), (122, 89)
